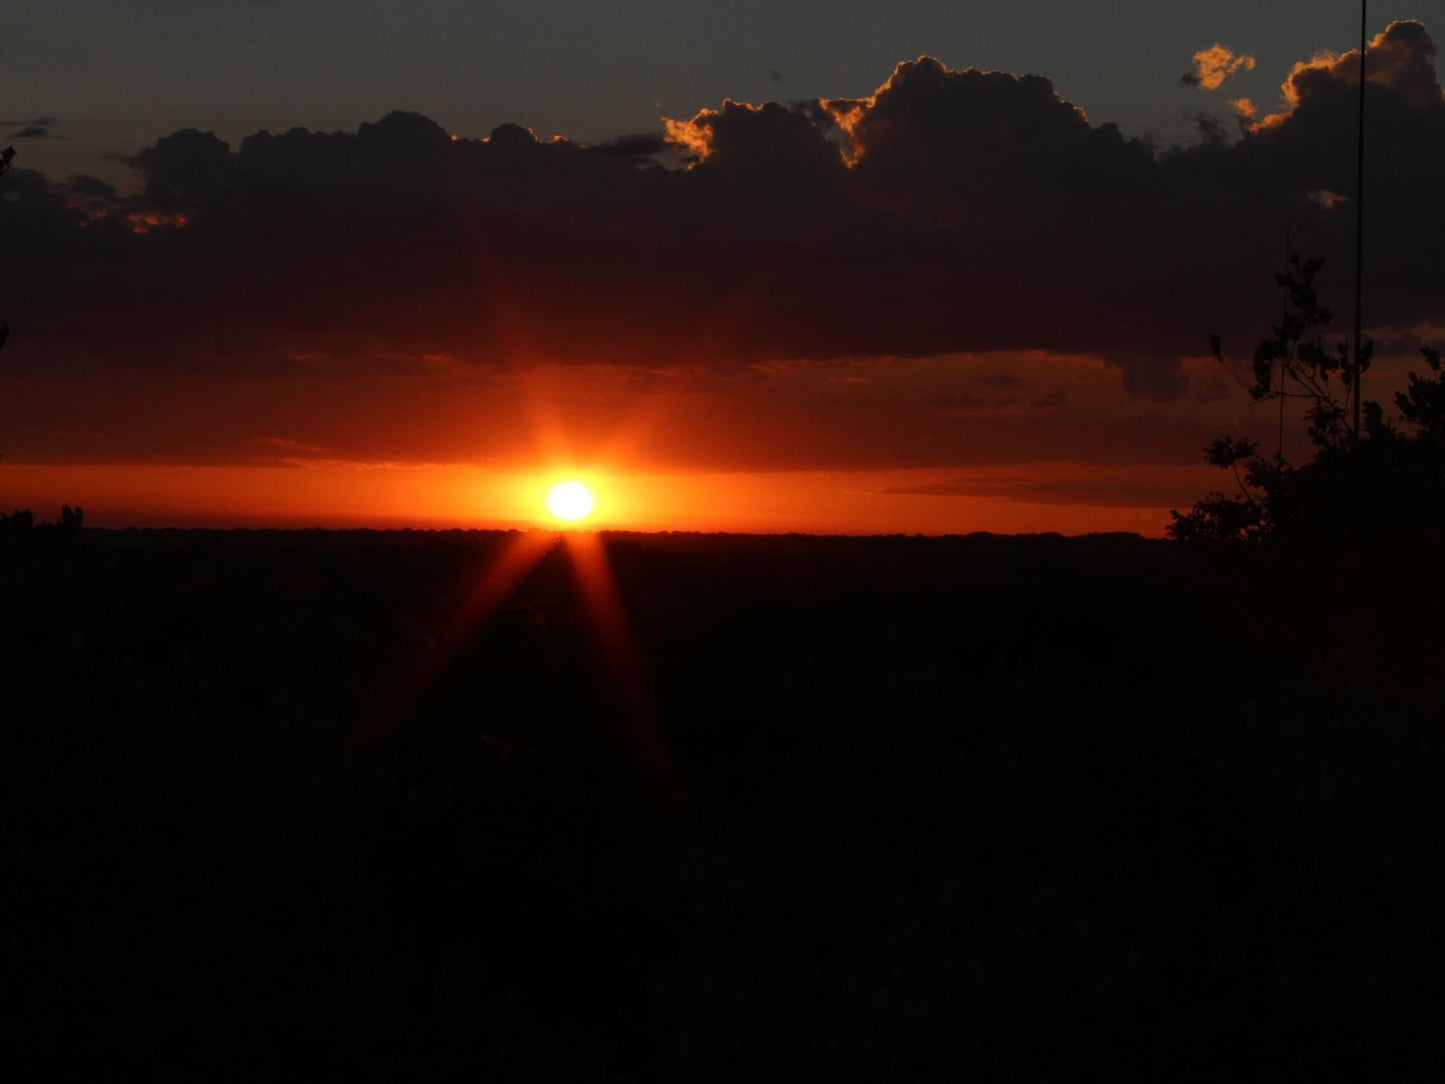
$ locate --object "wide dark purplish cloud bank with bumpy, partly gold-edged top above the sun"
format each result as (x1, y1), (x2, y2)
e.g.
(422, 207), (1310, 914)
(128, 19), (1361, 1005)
(0, 23), (1445, 462)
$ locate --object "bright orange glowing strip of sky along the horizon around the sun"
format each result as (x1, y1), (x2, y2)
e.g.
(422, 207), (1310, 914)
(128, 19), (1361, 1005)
(0, 463), (1218, 536)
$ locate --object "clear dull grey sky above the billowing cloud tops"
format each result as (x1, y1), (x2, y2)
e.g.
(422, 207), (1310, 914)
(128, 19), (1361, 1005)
(0, 0), (1445, 182)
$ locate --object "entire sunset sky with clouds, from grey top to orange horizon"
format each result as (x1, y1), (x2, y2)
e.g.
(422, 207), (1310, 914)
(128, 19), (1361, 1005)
(0, 0), (1445, 535)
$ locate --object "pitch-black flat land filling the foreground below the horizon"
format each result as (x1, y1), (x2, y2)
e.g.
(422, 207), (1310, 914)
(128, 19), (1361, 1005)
(0, 530), (1445, 1080)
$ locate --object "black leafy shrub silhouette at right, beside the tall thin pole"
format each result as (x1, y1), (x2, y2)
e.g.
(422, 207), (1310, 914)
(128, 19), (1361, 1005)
(1166, 256), (1445, 545)
